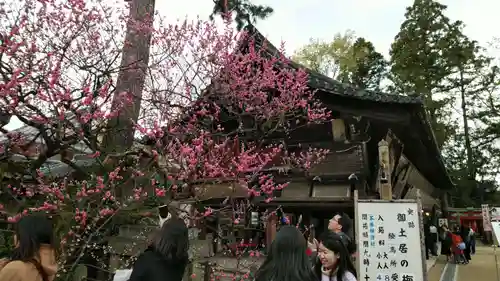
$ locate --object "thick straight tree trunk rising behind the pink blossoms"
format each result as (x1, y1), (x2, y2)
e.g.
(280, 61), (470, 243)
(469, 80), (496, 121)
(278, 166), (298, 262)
(103, 0), (155, 153)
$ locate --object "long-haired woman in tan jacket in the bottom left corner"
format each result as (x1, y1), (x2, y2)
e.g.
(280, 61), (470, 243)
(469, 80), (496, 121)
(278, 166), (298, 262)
(0, 215), (57, 281)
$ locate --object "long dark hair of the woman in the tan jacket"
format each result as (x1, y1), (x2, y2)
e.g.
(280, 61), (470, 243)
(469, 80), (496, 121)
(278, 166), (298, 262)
(10, 215), (54, 281)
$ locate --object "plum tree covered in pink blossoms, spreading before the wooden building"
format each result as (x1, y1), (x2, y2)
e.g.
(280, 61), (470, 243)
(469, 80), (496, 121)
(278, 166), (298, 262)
(0, 0), (329, 278)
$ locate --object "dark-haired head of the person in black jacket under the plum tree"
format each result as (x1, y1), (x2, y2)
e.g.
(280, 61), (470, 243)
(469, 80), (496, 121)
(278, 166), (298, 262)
(151, 218), (189, 263)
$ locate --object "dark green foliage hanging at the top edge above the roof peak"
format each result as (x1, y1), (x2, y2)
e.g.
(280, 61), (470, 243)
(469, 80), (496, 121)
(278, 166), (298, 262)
(210, 0), (273, 30)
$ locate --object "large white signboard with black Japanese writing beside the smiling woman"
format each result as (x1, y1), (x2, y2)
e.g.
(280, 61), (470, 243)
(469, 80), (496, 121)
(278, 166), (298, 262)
(356, 201), (426, 281)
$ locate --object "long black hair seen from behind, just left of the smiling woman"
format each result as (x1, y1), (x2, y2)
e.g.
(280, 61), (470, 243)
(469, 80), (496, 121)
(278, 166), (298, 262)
(255, 226), (316, 281)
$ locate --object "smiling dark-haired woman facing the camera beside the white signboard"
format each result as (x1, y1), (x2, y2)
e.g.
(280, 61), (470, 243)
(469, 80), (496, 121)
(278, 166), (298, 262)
(314, 231), (356, 281)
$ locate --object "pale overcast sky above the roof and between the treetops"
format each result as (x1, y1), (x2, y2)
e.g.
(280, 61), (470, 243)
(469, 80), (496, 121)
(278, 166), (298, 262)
(7, 0), (500, 129)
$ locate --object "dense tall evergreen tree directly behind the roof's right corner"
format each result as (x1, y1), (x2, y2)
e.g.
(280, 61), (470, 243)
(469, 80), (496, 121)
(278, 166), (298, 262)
(390, 0), (462, 147)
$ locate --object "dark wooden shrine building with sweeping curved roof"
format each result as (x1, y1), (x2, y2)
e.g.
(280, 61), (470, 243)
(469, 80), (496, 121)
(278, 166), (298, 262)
(186, 26), (454, 252)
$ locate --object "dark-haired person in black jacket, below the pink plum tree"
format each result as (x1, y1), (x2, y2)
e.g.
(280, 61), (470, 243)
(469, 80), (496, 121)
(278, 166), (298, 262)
(129, 218), (189, 281)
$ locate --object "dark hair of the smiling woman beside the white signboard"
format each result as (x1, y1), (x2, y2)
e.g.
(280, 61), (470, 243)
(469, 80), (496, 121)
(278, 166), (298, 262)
(314, 231), (356, 280)
